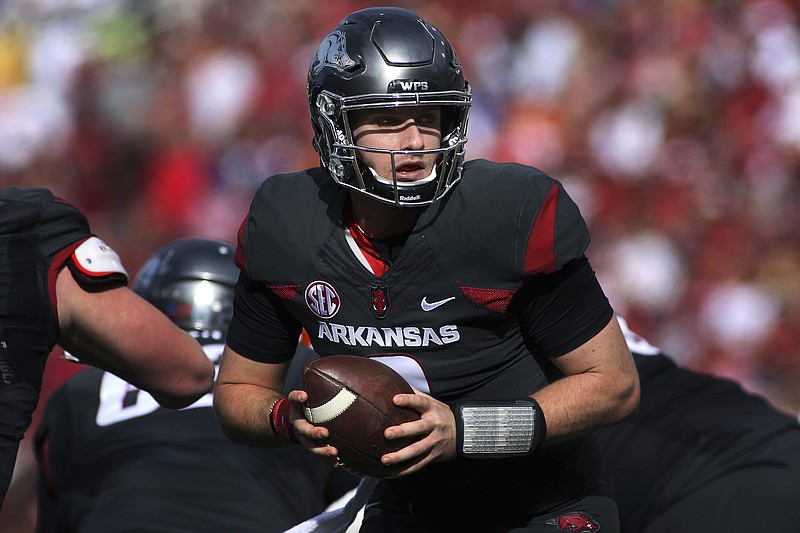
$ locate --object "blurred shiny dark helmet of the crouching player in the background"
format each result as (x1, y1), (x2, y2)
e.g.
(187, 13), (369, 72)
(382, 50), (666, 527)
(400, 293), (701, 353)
(131, 237), (239, 339)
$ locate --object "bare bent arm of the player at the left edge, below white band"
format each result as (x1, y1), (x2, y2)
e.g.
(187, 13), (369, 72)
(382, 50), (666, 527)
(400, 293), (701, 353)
(56, 268), (214, 408)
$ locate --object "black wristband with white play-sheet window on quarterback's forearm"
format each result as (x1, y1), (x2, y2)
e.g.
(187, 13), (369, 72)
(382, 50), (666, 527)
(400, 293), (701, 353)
(450, 398), (547, 458)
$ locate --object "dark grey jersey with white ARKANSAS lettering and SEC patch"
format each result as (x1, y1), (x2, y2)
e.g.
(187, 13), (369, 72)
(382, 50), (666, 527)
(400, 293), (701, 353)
(228, 161), (611, 401)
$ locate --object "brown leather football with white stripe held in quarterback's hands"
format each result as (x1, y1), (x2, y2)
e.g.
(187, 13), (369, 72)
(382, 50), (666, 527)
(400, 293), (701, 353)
(303, 355), (419, 477)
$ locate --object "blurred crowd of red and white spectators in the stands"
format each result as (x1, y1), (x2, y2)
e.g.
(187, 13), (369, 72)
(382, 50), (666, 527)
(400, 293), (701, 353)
(0, 0), (800, 524)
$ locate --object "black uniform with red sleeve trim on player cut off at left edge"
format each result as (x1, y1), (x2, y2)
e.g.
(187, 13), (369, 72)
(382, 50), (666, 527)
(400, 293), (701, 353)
(0, 187), (119, 505)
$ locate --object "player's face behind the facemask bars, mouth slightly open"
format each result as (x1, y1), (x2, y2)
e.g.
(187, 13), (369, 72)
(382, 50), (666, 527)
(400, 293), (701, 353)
(350, 106), (442, 183)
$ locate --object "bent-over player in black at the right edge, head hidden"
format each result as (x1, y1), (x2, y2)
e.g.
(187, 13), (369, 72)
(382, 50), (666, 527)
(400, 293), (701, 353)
(598, 321), (800, 533)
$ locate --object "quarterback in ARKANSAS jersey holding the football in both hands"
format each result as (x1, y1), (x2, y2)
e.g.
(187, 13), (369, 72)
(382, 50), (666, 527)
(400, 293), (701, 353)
(214, 8), (639, 532)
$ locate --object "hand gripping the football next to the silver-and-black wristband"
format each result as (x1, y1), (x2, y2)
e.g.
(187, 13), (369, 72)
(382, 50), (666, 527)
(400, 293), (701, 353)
(381, 389), (456, 477)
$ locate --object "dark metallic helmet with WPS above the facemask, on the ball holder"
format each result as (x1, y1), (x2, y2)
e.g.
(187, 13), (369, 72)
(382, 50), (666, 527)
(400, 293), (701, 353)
(307, 7), (472, 206)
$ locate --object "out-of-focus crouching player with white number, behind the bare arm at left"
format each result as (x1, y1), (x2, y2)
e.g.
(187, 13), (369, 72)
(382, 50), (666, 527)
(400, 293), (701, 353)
(35, 238), (357, 533)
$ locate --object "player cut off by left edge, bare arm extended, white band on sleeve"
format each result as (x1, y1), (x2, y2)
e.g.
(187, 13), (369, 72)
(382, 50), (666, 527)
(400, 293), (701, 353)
(0, 187), (213, 506)
